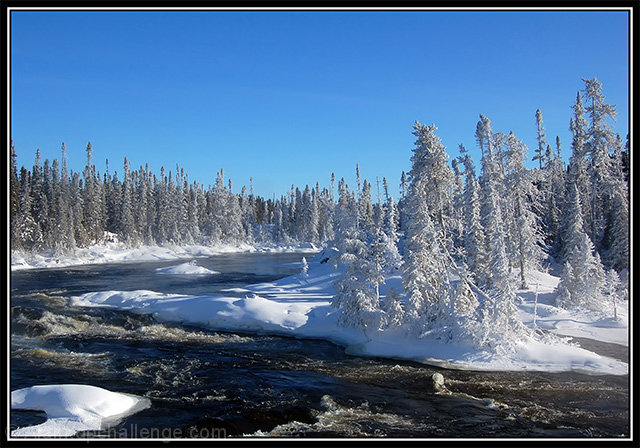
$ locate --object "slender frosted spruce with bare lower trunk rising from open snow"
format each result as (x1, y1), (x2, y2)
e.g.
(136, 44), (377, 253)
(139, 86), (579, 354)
(505, 132), (544, 289)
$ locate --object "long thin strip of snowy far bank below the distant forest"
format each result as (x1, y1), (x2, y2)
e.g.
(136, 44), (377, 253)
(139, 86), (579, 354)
(11, 238), (318, 271)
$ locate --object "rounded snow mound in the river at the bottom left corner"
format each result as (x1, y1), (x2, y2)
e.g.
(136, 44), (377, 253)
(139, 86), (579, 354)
(11, 384), (150, 437)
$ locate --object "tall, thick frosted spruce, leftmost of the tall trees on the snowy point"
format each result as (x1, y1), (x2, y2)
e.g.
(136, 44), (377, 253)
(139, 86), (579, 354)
(402, 121), (453, 335)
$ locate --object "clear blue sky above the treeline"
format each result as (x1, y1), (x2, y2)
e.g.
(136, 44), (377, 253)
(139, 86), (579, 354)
(11, 11), (629, 199)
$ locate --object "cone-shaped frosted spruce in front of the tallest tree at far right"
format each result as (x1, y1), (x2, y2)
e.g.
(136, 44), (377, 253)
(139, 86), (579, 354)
(557, 184), (605, 310)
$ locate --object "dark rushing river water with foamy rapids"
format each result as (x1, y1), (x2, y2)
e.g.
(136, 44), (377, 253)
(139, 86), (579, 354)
(10, 253), (630, 439)
